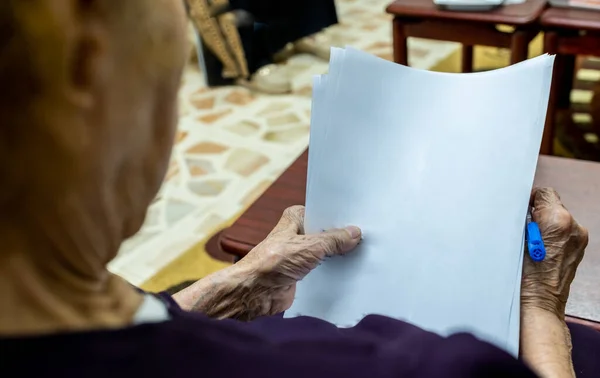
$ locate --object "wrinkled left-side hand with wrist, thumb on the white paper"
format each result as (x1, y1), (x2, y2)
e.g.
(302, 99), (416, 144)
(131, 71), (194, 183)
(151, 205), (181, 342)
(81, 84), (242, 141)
(174, 206), (361, 320)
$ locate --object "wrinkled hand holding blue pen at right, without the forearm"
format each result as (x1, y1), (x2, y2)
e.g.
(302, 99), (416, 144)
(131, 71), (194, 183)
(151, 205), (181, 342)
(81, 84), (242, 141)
(521, 188), (588, 319)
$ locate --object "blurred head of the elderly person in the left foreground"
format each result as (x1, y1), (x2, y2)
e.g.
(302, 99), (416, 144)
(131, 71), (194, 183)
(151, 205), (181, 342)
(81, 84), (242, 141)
(0, 0), (188, 330)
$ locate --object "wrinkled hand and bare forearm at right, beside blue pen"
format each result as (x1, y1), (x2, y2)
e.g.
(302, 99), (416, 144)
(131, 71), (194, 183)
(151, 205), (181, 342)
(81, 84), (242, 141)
(520, 188), (588, 377)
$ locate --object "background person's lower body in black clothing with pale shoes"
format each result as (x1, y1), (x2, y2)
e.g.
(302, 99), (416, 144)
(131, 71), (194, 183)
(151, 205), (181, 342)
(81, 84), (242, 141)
(186, 0), (337, 94)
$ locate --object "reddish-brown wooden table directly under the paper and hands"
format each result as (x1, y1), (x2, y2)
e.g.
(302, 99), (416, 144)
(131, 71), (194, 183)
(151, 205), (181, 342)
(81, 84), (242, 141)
(220, 152), (600, 326)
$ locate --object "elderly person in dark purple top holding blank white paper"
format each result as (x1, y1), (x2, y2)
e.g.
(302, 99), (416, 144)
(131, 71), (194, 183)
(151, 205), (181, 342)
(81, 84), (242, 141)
(0, 0), (597, 378)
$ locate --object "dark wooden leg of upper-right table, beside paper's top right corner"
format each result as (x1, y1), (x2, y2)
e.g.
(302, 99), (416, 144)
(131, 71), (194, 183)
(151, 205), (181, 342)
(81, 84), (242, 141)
(540, 31), (561, 155)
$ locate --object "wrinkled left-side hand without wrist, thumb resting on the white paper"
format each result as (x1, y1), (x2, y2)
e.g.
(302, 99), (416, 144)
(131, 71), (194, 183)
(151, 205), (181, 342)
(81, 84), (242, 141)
(238, 206), (361, 314)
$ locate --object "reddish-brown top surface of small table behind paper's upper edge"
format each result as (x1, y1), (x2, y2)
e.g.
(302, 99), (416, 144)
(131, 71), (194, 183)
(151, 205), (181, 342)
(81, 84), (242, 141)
(386, 0), (546, 26)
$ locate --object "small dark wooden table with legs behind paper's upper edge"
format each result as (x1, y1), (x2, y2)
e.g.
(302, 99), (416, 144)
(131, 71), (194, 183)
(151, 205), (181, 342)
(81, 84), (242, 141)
(386, 0), (546, 72)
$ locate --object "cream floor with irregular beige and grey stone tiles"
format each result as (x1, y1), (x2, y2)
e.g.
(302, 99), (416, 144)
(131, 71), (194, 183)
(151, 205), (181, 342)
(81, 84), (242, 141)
(110, 0), (457, 285)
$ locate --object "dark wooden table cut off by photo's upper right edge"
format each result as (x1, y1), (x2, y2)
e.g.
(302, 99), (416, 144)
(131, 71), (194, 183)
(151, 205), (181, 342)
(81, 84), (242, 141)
(540, 8), (600, 157)
